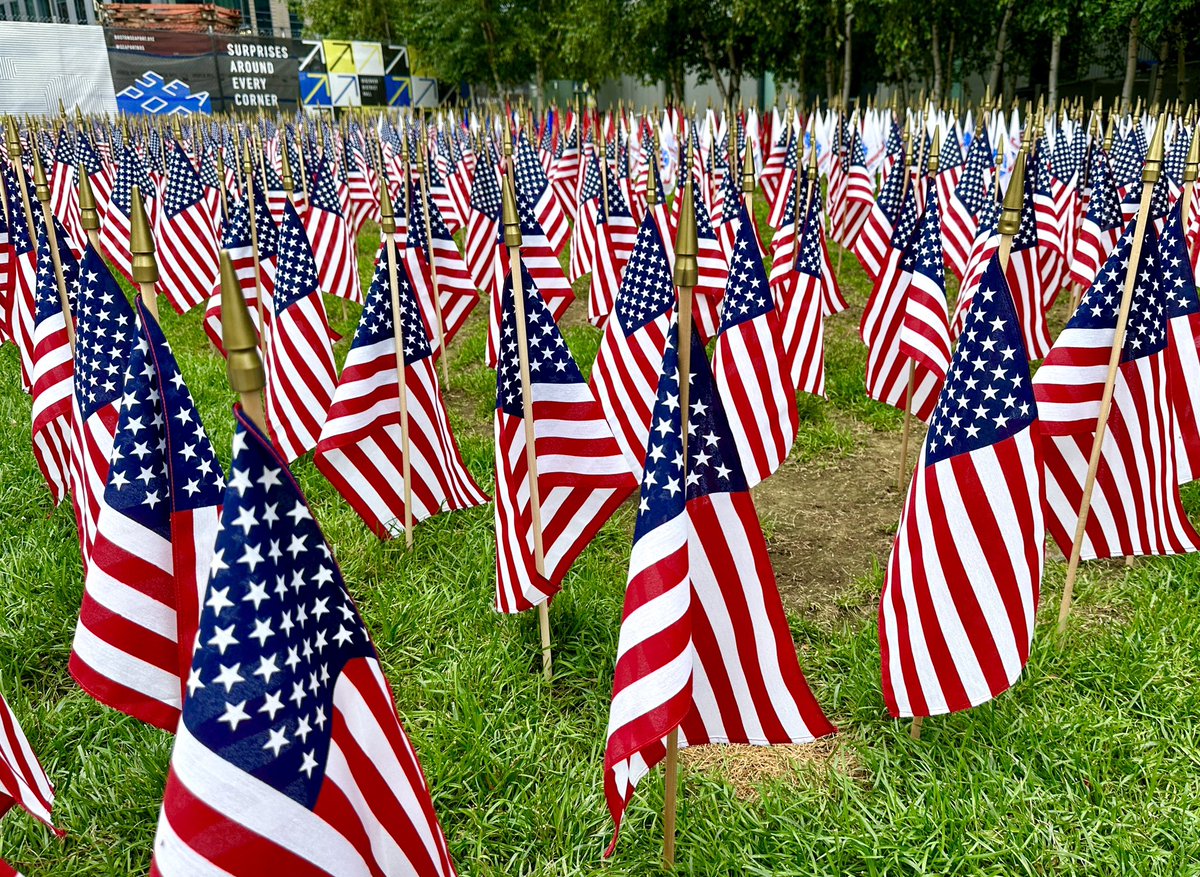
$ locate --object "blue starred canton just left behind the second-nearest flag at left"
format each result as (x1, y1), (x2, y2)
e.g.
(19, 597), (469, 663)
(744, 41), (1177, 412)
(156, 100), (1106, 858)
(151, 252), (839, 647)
(74, 246), (137, 419)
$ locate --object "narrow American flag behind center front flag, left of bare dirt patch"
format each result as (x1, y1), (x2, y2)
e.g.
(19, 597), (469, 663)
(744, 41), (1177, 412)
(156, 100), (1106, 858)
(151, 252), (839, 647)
(713, 198), (799, 487)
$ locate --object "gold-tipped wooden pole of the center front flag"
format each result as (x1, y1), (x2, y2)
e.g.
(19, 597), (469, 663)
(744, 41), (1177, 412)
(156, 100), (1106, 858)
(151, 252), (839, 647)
(662, 125), (700, 869)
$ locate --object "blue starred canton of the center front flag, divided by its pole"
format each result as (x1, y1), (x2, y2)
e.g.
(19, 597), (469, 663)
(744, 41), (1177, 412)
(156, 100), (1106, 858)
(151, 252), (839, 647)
(634, 319), (746, 541)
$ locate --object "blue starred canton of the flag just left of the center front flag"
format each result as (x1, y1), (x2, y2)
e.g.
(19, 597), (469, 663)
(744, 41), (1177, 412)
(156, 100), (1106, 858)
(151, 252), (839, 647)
(496, 263), (583, 418)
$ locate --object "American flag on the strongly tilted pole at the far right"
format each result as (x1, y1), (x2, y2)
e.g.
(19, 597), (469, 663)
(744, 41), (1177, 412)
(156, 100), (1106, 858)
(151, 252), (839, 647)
(1033, 223), (1200, 560)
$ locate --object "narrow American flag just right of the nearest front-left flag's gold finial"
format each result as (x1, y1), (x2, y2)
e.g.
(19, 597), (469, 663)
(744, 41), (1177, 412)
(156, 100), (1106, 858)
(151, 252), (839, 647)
(266, 202), (337, 461)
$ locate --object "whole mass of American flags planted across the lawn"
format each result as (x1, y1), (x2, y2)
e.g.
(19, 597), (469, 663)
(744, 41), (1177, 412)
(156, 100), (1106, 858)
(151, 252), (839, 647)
(0, 92), (1200, 875)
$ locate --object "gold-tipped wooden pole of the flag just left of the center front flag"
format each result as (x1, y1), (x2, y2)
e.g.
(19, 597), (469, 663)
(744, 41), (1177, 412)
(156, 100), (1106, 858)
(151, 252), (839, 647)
(500, 126), (554, 683)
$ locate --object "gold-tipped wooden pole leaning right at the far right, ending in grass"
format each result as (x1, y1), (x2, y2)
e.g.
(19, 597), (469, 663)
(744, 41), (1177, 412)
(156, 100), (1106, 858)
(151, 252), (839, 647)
(1058, 114), (1166, 633)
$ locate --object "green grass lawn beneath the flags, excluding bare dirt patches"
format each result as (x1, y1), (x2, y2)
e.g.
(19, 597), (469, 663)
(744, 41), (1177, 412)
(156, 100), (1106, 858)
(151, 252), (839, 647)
(0, 200), (1200, 877)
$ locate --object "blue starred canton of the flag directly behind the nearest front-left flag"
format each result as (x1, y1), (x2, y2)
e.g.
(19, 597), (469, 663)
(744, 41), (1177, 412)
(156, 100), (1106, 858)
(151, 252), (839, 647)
(104, 301), (224, 539)
